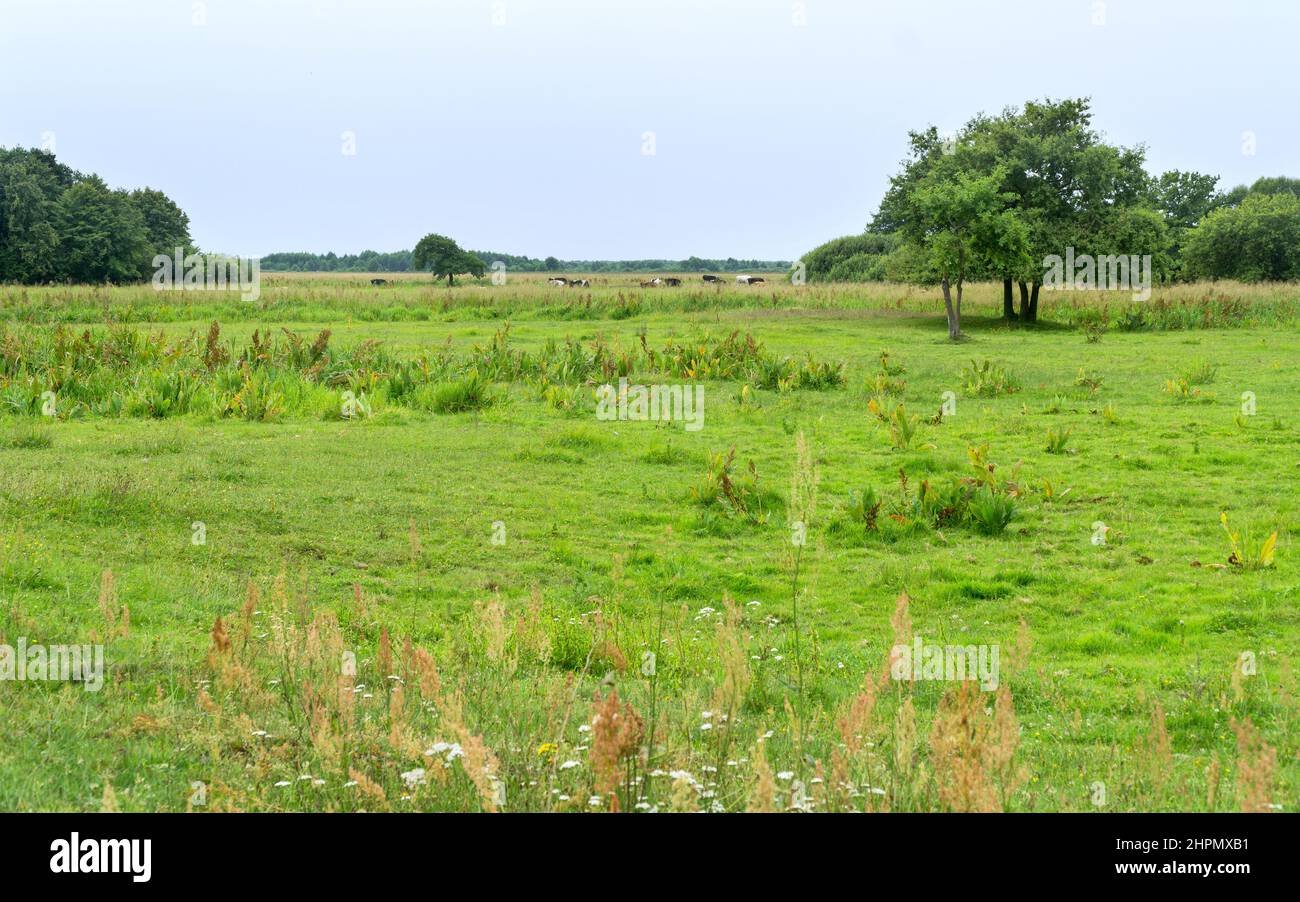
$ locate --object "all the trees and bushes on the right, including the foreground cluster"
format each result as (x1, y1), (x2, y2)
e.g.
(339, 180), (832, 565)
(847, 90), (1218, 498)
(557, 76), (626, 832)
(802, 97), (1300, 331)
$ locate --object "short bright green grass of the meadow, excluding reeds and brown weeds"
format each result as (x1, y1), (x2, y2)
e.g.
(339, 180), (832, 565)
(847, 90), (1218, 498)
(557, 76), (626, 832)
(0, 280), (1300, 810)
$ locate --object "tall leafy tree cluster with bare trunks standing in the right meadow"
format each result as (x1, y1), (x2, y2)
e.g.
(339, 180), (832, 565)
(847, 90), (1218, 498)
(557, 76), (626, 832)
(870, 99), (1170, 324)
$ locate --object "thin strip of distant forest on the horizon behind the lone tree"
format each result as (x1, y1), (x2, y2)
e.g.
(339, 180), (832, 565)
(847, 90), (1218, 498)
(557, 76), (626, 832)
(261, 251), (790, 273)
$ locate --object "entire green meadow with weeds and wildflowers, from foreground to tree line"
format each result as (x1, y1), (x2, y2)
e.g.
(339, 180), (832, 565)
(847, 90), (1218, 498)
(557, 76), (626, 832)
(0, 277), (1300, 811)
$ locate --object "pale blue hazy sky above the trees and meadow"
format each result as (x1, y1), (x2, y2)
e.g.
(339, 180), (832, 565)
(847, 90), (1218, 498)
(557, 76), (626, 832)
(0, 0), (1300, 260)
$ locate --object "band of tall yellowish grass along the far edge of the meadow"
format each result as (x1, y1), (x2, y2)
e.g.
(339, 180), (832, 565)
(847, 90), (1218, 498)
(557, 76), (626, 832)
(0, 273), (1300, 337)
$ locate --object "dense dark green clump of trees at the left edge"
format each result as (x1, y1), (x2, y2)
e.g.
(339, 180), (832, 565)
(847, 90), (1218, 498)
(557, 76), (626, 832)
(0, 147), (196, 285)
